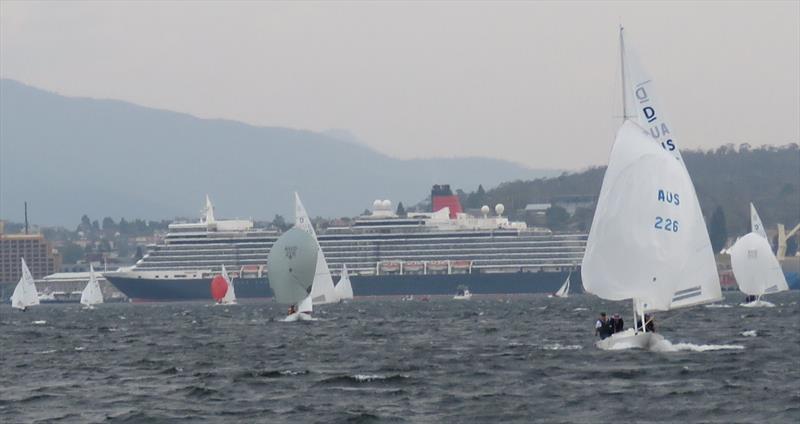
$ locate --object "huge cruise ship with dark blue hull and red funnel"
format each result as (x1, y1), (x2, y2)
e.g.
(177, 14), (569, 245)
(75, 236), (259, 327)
(103, 185), (587, 302)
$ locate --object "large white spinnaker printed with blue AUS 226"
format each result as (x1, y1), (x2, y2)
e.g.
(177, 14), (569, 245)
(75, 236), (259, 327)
(581, 121), (721, 310)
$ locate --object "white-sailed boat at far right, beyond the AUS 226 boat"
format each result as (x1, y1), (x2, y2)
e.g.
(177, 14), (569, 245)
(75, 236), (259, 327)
(730, 203), (789, 307)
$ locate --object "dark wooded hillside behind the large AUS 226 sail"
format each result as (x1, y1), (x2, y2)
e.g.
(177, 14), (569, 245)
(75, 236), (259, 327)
(456, 143), (800, 248)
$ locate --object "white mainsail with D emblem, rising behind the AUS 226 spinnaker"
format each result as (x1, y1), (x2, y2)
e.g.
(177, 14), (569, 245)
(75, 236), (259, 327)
(620, 29), (683, 163)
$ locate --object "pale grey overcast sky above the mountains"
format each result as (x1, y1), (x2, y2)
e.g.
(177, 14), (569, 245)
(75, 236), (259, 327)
(0, 0), (800, 169)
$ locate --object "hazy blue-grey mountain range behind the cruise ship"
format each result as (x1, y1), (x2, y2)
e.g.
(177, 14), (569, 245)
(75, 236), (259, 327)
(0, 79), (558, 226)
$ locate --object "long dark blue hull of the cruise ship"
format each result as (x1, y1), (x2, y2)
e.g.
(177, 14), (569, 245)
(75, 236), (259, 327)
(106, 271), (581, 302)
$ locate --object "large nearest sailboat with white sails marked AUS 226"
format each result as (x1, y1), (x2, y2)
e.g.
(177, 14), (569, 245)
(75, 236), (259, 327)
(581, 28), (722, 349)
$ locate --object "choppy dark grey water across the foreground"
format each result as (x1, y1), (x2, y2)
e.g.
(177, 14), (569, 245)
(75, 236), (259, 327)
(0, 292), (800, 423)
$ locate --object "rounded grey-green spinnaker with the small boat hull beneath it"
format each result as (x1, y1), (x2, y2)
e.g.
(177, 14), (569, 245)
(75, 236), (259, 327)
(267, 227), (319, 321)
